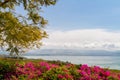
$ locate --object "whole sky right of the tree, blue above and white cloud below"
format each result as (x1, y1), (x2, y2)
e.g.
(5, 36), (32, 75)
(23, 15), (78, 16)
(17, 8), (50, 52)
(19, 0), (120, 51)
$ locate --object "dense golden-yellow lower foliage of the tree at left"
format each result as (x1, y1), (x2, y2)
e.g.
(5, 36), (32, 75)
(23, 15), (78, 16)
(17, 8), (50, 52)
(0, 12), (47, 55)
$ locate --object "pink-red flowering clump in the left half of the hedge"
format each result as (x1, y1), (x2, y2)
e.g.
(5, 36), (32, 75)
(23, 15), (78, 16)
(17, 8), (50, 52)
(16, 62), (42, 79)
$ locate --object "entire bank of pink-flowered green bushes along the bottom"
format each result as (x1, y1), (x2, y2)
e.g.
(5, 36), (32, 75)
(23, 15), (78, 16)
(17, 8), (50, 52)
(0, 57), (120, 80)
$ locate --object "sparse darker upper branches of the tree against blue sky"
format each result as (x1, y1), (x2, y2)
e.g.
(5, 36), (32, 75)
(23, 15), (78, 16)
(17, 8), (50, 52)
(0, 0), (57, 26)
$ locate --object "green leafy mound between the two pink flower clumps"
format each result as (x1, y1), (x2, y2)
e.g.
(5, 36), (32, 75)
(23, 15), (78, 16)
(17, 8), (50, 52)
(43, 67), (73, 80)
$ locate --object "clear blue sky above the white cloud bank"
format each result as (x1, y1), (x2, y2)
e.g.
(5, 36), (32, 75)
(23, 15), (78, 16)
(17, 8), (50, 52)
(42, 0), (120, 30)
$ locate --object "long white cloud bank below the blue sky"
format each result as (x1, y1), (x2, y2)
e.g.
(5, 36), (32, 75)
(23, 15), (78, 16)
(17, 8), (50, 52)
(43, 29), (120, 50)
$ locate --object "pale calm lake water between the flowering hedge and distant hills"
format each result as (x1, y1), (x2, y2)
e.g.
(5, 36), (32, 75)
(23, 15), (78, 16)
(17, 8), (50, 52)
(25, 56), (120, 70)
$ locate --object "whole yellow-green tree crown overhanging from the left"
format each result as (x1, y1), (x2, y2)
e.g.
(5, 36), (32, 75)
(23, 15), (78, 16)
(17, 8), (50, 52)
(0, 0), (56, 56)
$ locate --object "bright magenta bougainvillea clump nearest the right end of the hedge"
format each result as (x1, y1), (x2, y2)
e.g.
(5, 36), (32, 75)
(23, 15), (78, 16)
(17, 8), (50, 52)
(78, 65), (110, 80)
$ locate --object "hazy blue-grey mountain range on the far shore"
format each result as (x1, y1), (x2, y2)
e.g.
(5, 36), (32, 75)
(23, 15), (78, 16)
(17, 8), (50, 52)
(24, 49), (120, 56)
